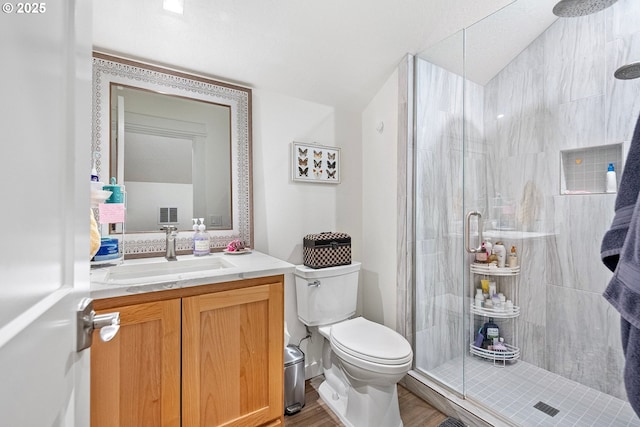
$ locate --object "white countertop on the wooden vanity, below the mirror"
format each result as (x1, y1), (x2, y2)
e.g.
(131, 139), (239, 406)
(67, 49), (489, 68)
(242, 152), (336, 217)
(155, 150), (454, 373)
(90, 251), (294, 299)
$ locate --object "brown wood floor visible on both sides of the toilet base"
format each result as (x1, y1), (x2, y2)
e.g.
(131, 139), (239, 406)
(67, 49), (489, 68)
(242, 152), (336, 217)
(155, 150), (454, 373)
(284, 376), (447, 427)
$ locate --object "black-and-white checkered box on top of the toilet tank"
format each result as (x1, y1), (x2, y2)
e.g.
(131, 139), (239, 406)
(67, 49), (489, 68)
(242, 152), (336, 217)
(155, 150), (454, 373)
(302, 232), (351, 268)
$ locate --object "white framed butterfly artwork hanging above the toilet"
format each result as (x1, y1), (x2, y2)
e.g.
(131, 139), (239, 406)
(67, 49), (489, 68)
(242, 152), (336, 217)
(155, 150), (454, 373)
(291, 142), (340, 184)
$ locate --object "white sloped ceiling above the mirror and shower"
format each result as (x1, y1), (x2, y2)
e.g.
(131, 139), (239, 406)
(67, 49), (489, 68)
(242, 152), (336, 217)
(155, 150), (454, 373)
(93, 0), (556, 111)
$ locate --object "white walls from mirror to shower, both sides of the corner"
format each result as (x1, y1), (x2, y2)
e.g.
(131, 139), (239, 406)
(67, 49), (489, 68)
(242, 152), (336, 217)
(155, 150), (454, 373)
(253, 64), (398, 377)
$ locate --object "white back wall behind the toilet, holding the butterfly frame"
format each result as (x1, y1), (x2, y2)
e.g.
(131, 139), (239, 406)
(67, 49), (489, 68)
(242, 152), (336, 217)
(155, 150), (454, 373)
(253, 90), (362, 376)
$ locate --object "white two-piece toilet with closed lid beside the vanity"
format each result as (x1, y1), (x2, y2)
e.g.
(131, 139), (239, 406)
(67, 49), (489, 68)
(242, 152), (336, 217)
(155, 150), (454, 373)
(294, 262), (413, 427)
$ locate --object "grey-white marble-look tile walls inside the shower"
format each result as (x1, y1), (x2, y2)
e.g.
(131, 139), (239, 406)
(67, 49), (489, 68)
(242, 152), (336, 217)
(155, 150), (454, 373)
(414, 0), (640, 404)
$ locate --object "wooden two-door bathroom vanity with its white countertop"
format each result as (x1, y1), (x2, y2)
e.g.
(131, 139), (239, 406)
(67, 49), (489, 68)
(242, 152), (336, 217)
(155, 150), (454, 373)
(91, 252), (293, 427)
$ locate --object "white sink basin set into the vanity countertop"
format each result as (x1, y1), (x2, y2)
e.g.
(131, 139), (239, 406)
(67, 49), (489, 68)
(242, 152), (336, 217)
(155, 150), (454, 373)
(105, 256), (235, 283)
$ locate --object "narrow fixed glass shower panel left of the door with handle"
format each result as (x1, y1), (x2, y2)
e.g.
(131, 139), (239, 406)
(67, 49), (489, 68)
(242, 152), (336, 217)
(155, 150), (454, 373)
(414, 32), (468, 396)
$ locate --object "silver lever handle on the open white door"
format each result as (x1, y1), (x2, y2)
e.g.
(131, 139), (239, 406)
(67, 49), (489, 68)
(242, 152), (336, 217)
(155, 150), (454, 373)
(76, 298), (120, 351)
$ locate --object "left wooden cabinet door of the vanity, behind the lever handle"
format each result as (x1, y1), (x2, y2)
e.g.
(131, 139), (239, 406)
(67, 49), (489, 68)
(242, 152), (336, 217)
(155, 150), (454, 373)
(91, 299), (181, 427)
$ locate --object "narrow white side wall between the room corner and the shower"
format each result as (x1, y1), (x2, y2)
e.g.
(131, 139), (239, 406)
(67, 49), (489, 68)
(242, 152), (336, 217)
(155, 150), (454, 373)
(361, 69), (398, 329)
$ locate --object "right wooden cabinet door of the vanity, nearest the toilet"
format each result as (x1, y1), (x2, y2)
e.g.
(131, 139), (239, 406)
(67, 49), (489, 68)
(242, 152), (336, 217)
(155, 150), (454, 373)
(182, 282), (284, 427)
